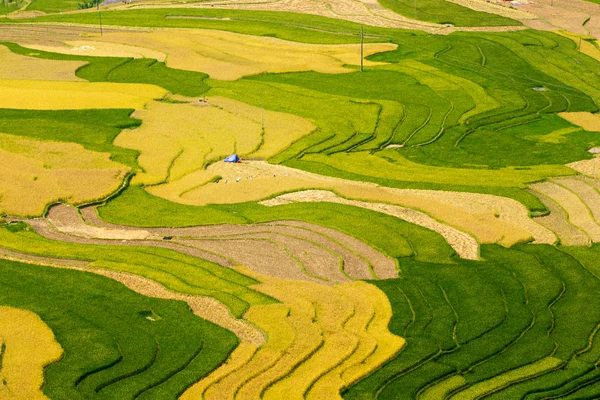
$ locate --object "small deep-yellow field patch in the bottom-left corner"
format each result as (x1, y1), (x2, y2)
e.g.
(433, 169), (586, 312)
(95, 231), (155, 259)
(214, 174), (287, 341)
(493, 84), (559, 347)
(0, 306), (63, 400)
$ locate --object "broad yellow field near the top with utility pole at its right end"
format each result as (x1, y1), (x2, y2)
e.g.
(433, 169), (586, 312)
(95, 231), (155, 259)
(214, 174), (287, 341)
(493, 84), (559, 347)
(81, 29), (396, 80)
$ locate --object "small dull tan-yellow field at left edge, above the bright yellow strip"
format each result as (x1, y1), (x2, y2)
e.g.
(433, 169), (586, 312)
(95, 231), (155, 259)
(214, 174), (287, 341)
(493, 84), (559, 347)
(0, 46), (86, 81)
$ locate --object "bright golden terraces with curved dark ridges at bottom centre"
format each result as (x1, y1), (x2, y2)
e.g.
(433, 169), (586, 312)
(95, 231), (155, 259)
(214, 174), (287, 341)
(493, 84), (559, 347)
(182, 269), (405, 399)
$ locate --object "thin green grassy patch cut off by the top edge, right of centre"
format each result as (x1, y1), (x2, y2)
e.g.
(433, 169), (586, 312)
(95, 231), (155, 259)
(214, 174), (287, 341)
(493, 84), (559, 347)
(380, 0), (521, 26)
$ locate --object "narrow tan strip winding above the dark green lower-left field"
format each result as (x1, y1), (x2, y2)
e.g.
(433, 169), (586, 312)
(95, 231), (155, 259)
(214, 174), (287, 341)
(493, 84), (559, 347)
(0, 248), (266, 346)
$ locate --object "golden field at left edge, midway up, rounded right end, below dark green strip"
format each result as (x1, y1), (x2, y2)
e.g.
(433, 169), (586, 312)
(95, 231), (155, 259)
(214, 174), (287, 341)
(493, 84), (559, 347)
(0, 134), (129, 216)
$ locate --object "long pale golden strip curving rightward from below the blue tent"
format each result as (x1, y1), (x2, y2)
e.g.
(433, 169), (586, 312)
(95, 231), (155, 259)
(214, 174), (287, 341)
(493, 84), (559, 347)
(163, 161), (555, 247)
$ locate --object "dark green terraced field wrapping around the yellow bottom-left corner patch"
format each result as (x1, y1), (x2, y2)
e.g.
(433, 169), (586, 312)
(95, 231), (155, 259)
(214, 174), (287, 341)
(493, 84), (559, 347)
(0, 260), (237, 399)
